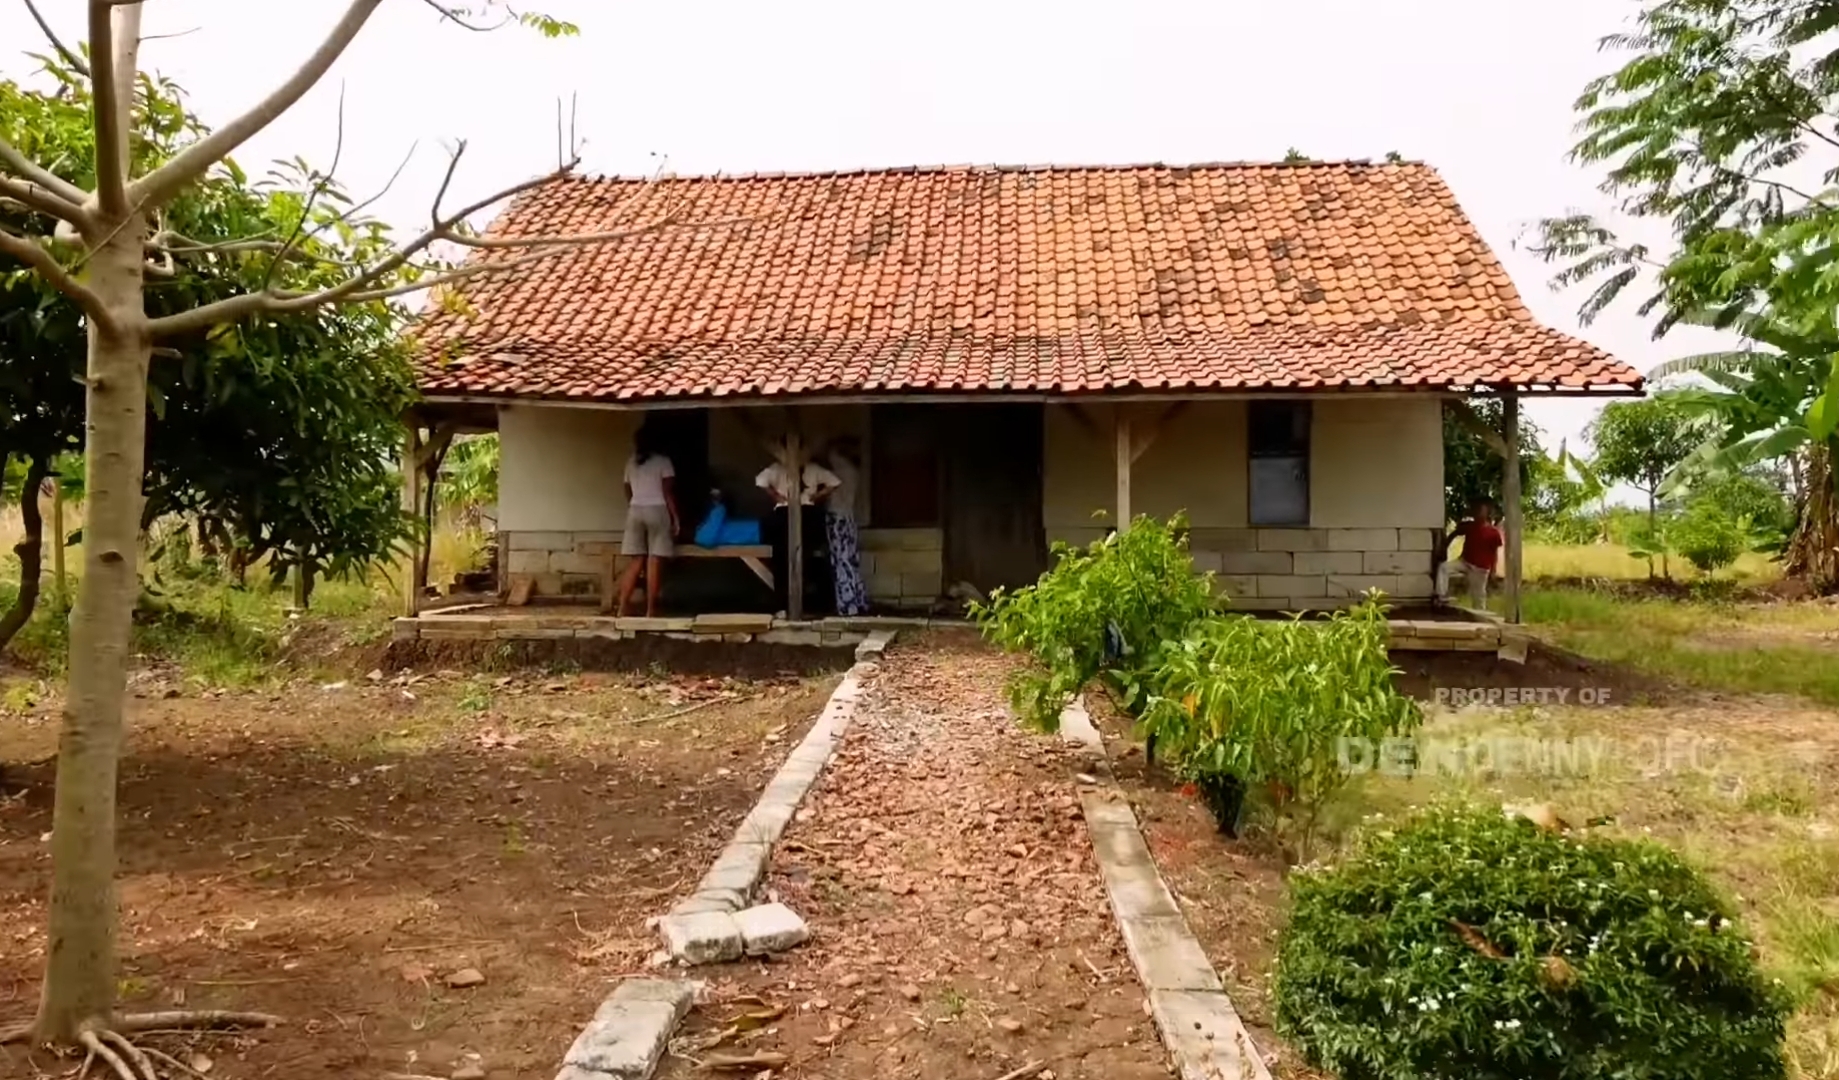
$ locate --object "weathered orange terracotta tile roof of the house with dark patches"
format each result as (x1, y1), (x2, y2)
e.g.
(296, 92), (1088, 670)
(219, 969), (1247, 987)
(417, 162), (1640, 399)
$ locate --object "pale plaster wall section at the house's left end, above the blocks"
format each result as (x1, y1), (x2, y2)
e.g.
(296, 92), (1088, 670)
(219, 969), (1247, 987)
(498, 405), (642, 532)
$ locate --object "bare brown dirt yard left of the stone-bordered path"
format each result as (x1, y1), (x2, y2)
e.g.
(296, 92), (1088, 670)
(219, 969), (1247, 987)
(0, 672), (835, 1080)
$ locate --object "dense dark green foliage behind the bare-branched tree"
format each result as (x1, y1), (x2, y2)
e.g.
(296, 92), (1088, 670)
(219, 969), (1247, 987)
(0, 66), (416, 614)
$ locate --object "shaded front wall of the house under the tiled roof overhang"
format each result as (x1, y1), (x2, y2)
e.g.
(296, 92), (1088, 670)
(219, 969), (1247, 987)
(406, 392), (1493, 633)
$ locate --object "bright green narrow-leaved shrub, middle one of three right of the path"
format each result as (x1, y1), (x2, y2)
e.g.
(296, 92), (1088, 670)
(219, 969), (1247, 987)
(1142, 594), (1422, 846)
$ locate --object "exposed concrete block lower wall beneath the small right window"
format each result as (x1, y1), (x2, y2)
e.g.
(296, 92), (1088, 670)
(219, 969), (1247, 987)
(1188, 528), (1436, 611)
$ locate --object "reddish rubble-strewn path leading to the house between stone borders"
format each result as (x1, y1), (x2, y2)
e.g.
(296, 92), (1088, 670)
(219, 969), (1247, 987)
(660, 633), (1168, 1080)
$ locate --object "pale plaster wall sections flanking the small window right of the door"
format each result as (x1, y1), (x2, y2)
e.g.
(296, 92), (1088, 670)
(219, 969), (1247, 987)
(1043, 396), (1444, 543)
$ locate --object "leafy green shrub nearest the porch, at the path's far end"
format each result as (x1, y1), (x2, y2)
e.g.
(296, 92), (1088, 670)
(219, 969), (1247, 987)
(971, 515), (1214, 732)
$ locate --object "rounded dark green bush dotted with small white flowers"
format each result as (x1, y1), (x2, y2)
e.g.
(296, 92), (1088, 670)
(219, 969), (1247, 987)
(1274, 808), (1788, 1080)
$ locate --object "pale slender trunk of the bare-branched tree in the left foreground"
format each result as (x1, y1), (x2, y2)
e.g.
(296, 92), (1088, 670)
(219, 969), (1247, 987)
(33, 219), (151, 1045)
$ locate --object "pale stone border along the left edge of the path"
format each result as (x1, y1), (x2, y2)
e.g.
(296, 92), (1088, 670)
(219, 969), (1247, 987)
(555, 629), (894, 1080)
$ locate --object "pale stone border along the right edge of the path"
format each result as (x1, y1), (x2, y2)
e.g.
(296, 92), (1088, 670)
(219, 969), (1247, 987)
(1059, 697), (1271, 1080)
